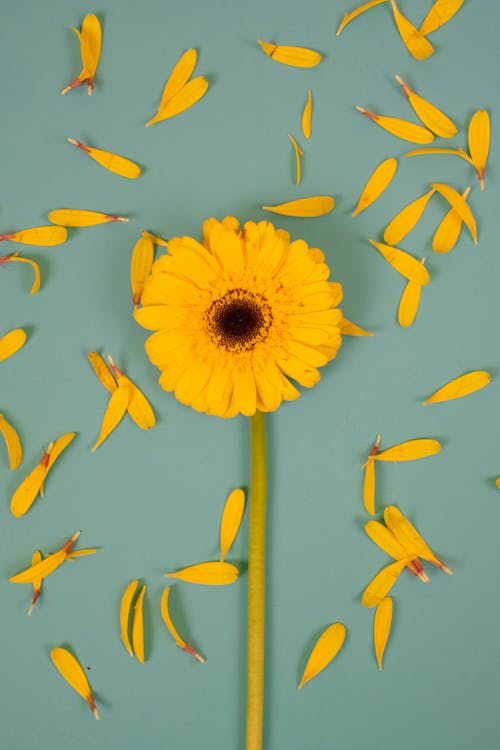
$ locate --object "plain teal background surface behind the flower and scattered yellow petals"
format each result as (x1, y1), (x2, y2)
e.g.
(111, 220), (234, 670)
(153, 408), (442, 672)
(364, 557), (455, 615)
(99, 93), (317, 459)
(0, 0), (500, 750)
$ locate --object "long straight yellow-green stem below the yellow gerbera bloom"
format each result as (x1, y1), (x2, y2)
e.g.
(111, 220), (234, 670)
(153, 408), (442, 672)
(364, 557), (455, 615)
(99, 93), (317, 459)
(246, 411), (266, 750)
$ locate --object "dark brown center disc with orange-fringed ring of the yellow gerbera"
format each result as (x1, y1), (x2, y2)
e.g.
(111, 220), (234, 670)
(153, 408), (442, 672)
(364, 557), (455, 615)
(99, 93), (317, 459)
(207, 289), (272, 351)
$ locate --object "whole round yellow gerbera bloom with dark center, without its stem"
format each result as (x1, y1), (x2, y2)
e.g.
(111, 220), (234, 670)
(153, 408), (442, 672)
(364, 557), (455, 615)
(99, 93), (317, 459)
(135, 216), (342, 417)
